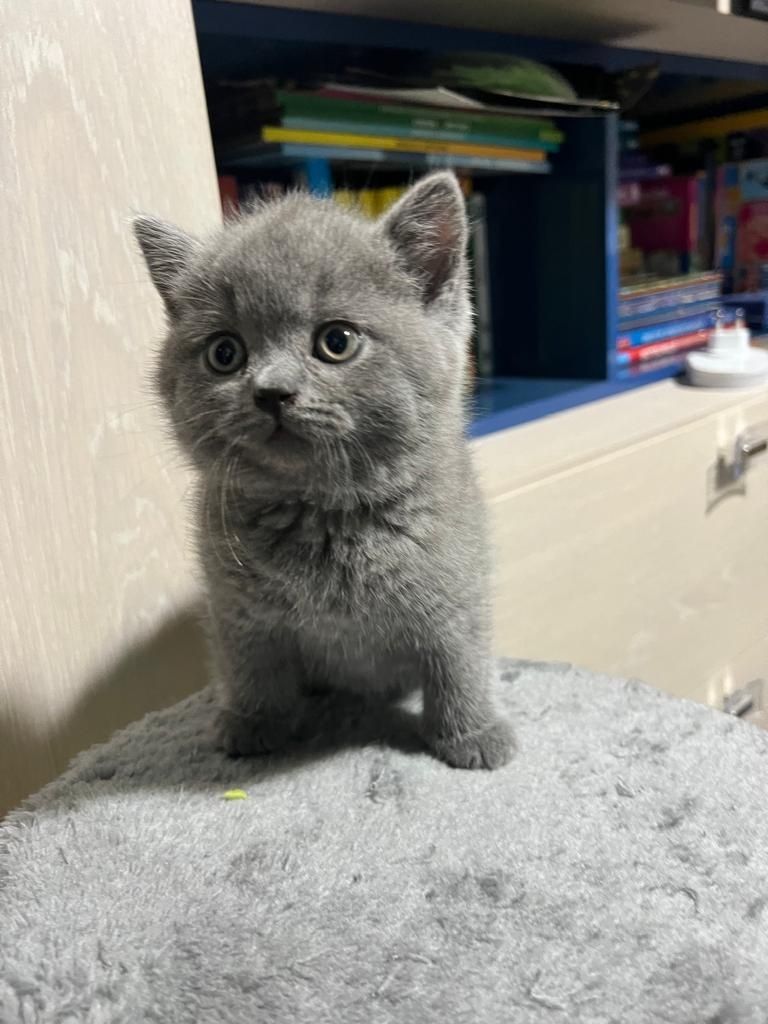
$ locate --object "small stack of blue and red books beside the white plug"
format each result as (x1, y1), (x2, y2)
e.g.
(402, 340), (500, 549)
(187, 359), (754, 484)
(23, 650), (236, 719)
(615, 272), (722, 367)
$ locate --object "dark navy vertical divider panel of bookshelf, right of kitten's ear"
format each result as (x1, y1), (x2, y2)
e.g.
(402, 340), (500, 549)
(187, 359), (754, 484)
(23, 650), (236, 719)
(478, 116), (618, 380)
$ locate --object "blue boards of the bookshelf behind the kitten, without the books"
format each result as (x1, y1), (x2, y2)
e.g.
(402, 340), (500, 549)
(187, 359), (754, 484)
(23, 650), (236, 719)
(194, 0), (768, 436)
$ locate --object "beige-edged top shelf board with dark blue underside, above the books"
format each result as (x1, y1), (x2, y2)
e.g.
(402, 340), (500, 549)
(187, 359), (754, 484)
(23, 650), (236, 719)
(194, 0), (766, 73)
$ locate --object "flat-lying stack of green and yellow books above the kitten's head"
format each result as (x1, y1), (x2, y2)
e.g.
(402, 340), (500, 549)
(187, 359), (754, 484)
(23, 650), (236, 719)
(219, 84), (563, 173)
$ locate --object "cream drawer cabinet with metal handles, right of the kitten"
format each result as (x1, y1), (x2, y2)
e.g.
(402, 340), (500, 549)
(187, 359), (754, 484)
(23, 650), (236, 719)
(476, 382), (768, 703)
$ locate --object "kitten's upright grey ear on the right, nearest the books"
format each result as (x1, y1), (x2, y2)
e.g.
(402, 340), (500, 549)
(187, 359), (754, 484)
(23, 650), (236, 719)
(381, 171), (467, 303)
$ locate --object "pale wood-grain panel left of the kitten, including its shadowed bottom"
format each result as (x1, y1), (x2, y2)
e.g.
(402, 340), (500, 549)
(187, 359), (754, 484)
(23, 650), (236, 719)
(0, 0), (219, 814)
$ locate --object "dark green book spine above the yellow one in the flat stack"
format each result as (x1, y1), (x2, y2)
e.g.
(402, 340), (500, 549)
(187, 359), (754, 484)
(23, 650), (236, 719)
(278, 92), (563, 143)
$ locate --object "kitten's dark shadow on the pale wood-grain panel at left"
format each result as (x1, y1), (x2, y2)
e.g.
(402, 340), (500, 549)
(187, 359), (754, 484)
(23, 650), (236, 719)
(0, 608), (208, 818)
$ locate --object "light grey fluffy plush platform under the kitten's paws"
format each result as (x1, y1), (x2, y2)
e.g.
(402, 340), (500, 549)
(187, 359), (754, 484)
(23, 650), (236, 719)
(0, 663), (768, 1024)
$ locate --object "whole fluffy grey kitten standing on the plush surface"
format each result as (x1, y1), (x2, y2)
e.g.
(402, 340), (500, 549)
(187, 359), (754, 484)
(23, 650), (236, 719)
(135, 173), (513, 768)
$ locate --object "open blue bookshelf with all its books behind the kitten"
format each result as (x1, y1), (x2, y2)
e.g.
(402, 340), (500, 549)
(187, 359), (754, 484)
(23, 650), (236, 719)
(193, 0), (768, 433)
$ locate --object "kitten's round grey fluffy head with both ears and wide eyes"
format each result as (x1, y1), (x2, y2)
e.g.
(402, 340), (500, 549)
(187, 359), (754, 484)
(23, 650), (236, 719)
(137, 175), (469, 498)
